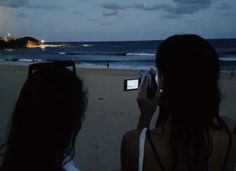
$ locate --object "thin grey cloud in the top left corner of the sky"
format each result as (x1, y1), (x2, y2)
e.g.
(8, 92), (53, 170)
(0, 0), (63, 10)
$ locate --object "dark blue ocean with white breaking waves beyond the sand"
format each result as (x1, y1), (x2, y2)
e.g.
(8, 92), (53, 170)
(0, 39), (236, 72)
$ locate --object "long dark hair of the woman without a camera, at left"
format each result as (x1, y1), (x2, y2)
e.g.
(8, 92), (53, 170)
(0, 62), (87, 171)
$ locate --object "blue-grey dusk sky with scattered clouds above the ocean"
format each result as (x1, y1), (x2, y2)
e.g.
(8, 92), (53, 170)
(0, 0), (236, 41)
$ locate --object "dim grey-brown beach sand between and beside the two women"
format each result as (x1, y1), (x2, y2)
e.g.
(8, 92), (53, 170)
(0, 64), (236, 171)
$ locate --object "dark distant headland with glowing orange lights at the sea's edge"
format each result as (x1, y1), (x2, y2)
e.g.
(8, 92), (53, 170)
(0, 36), (66, 49)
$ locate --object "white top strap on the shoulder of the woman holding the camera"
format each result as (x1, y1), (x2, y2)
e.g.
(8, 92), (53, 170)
(138, 128), (147, 171)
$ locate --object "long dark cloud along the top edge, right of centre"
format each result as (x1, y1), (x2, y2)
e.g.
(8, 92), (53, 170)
(100, 0), (213, 18)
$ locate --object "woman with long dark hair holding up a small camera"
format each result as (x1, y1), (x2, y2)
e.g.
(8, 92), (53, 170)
(121, 35), (236, 171)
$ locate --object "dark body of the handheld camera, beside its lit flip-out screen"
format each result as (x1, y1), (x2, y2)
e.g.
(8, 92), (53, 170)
(140, 68), (158, 99)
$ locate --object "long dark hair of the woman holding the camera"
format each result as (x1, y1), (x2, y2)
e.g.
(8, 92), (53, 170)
(156, 35), (231, 171)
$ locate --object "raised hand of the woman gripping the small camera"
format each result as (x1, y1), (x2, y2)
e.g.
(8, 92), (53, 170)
(137, 77), (161, 129)
